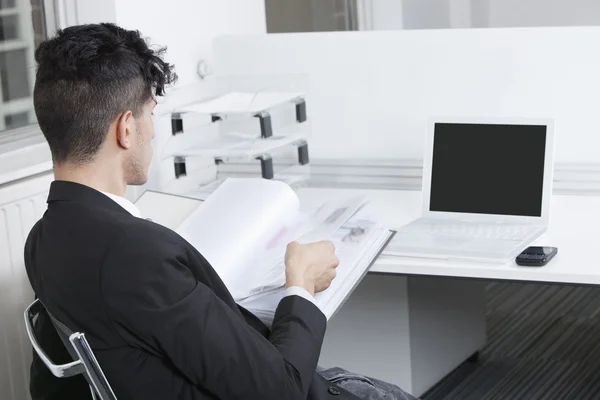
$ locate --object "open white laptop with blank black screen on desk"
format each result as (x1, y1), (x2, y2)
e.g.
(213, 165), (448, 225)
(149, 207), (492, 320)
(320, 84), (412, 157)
(386, 118), (554, 263)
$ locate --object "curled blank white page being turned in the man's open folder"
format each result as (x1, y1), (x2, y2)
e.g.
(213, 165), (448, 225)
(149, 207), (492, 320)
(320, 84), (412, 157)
(177, 178), (299, 299)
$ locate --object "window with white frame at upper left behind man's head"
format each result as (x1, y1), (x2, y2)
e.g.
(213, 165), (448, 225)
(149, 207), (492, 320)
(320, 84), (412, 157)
(0, 0), (51, 131)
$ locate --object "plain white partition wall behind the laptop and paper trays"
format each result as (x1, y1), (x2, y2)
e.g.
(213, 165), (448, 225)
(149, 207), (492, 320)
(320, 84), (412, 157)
(214, 27), (600, 164)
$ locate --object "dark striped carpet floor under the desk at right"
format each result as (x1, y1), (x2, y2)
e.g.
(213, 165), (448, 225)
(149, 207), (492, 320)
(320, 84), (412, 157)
(423, 283), (600, 400)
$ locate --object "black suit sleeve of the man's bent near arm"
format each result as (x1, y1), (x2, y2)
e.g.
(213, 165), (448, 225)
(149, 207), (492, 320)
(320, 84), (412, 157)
(101, 233), (326, 400)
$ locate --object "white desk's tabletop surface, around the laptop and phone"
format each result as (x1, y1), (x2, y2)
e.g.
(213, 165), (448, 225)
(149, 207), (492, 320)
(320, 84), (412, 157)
(299, 188), (600, 285)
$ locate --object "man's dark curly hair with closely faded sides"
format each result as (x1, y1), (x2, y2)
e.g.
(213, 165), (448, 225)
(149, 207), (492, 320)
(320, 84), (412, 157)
(33, 23), (177, 163)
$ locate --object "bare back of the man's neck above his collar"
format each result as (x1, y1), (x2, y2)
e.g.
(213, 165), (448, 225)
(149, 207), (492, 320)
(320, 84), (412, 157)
(54, 163), (127, 197)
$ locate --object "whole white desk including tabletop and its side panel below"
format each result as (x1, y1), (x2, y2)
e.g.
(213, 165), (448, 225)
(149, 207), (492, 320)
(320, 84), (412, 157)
(299, 188), (600, 396)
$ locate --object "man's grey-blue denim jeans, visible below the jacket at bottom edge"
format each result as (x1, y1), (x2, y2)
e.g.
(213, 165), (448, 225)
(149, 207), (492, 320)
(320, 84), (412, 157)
(317, 368), (418, 400)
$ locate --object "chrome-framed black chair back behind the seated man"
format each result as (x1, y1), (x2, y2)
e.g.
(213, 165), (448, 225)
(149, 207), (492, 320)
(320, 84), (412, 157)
(25, 299), (117, 400)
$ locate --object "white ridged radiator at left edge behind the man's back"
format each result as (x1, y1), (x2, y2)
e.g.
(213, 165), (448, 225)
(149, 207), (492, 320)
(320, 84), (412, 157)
(0, 175), (52, 400)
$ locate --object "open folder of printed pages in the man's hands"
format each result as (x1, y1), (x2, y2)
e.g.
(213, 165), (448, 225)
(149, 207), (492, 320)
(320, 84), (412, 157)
(176, 178), (391, 323)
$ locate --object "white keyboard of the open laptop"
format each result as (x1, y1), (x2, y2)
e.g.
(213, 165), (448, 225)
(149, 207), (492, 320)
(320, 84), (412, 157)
(402, 221), (535, 240)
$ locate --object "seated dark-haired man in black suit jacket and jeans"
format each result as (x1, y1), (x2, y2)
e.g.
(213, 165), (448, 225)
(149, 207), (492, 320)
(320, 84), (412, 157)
(25, 24), (418, 400)
